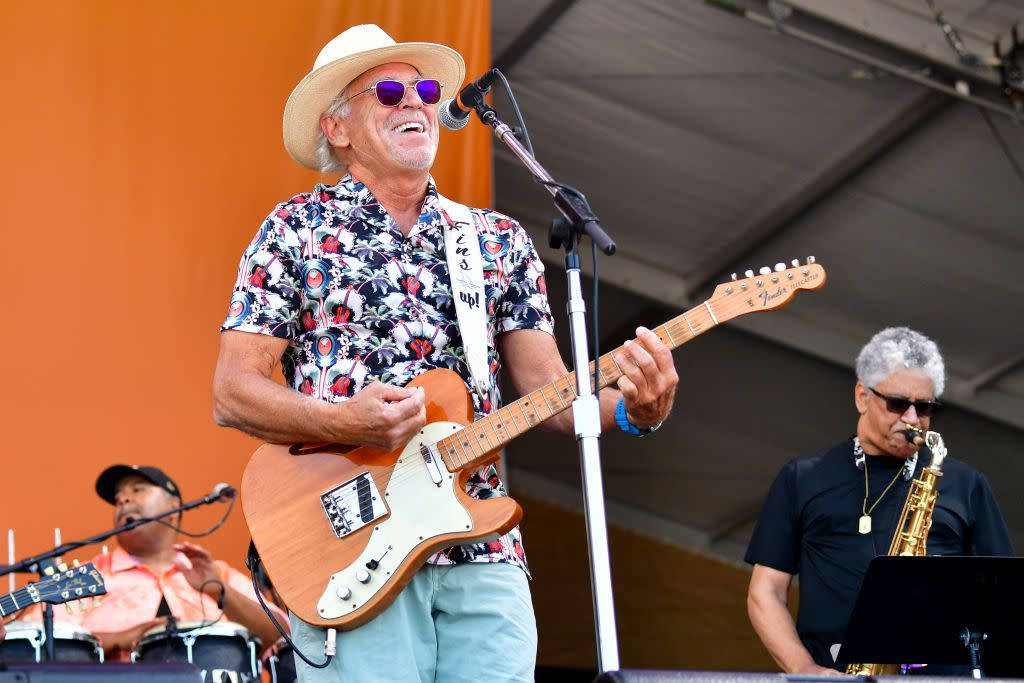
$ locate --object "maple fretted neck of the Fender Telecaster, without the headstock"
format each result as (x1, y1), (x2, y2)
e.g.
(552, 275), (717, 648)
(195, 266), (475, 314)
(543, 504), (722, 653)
(437, 300), (716, 472)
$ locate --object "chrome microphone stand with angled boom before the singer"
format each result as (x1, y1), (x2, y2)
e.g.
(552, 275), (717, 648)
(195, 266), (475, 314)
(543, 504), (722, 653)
(462, 97), (618, 672)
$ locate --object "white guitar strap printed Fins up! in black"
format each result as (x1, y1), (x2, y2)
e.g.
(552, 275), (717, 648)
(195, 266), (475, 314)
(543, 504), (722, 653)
(437, 195), (490, 398)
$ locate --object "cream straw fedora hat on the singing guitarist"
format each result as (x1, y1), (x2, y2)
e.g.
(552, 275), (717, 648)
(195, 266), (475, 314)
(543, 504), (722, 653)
(284, 24), (466, 170)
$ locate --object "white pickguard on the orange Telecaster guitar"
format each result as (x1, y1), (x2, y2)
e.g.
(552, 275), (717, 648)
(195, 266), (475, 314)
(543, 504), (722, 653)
(316, 422), (473, 620)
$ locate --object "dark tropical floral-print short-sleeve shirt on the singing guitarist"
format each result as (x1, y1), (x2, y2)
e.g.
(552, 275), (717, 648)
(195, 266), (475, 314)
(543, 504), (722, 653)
(221, 176), (553, 569)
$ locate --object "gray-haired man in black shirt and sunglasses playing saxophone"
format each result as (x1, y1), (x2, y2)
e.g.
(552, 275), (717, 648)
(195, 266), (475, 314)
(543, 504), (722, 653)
(745, 327), (1014, 674)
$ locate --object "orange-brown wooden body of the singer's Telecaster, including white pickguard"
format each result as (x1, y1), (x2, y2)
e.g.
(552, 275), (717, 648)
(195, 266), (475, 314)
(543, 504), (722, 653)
(242, 370), (522, 630)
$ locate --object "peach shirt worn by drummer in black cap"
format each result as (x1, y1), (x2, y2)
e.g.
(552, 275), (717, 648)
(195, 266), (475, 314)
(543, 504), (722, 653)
(25, 548), (288, 661)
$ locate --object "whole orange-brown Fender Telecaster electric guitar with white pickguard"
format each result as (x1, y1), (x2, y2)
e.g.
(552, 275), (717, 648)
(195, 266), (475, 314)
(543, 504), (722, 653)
(242, 259), (825, 630)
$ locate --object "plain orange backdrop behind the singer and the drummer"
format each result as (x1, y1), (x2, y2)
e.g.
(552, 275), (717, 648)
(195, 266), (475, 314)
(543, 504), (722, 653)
(0, 0), (492, 581)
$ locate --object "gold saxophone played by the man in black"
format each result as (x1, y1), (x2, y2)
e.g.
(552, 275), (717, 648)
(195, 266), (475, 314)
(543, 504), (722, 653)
(846, 425), (946, 676)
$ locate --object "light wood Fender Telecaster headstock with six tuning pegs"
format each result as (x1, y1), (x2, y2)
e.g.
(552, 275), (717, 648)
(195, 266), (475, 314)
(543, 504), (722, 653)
(709, 256), (825, 323)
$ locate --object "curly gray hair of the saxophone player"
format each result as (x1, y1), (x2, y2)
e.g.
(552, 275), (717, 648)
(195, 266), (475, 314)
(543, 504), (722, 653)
(857, 328), (946, 397)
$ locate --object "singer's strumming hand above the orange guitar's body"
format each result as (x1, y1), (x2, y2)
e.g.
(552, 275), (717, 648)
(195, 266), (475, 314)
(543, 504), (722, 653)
(329, 382), (427, 453)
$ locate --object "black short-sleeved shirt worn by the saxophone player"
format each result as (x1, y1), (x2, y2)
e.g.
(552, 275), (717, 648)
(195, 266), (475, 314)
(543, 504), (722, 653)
(745, 439), (1014, 669)
